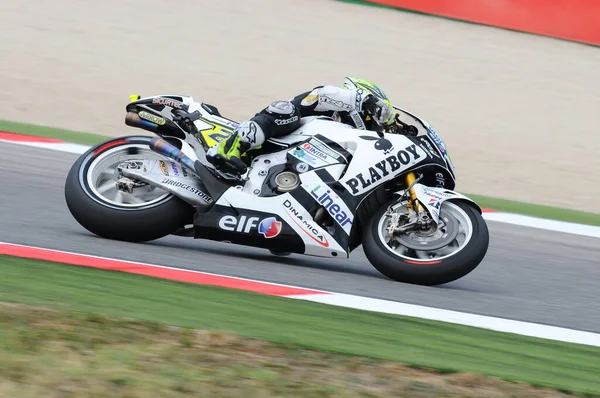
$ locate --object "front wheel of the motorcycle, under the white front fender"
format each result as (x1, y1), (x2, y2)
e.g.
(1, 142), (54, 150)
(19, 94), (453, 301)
(363, 202), (489, 285)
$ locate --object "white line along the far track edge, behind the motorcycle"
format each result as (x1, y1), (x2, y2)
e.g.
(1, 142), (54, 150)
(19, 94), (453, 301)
(0, 139), (600, 238)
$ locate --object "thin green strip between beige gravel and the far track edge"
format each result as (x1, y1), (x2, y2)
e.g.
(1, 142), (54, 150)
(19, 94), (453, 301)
(0, 121), (600, 222)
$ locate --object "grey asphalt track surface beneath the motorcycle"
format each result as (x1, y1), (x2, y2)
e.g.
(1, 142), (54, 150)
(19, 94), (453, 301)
(0, 143), (600, 333)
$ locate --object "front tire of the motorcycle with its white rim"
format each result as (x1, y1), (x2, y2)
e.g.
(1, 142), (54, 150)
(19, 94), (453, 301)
(363, 201), (489, 286)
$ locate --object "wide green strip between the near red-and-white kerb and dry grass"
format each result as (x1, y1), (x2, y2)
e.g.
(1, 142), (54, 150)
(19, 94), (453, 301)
(0, 256), (600, 394)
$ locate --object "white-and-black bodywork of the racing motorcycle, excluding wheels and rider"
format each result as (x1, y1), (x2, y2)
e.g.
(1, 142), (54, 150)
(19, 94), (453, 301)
(64, 95), (487, 283)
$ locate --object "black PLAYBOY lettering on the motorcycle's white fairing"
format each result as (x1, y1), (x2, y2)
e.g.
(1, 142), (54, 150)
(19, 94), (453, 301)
(345, 144), (426, 195)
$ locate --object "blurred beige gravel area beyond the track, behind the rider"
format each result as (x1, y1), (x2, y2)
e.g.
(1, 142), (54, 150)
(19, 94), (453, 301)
(0, 0), (600, 212)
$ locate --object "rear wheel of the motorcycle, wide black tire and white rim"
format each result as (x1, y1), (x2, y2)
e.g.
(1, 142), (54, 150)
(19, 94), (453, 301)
(65, 136), (194, 242)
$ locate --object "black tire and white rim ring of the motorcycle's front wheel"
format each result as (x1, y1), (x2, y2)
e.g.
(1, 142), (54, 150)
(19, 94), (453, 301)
(363, 201), (489, 286)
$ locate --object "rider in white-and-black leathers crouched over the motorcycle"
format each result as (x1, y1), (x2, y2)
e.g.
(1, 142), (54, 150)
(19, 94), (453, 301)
(206, 77), (396, 174)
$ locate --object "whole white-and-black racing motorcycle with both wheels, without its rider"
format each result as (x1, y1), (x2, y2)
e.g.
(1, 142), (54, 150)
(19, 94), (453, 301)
(65, 95), (489, 285)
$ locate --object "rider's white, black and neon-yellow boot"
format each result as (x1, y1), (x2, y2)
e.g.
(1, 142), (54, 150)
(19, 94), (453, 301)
(206, 120), (265, 174)
